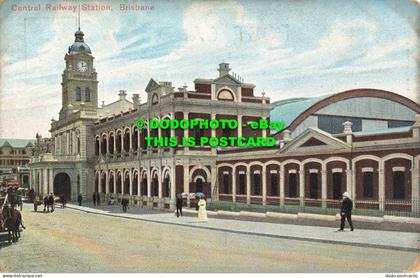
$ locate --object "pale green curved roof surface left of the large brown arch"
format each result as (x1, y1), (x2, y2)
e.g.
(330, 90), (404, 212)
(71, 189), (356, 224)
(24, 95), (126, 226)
(270, 94), (332, 128)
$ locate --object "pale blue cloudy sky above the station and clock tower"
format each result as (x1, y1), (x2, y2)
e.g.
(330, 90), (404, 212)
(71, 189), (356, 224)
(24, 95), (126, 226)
(0, 0), (418, 138)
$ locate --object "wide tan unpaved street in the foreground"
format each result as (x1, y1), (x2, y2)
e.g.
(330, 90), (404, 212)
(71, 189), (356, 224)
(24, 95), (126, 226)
(0, 205), (417, 272)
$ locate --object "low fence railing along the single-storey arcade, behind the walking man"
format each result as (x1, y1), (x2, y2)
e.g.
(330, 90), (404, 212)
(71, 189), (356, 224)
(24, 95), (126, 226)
(207, 199), (420, 217)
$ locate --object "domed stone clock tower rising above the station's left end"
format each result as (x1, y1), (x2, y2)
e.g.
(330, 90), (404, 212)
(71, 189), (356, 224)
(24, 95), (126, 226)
(59, 28), (98, 120)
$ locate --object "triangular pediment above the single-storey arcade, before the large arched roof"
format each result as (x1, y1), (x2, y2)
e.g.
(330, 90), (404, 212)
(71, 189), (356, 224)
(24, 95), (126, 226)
(280, 128), (351, 153)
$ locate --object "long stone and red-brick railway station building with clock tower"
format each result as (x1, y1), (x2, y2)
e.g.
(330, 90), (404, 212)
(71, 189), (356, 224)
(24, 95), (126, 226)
(30, 30), (420, 211)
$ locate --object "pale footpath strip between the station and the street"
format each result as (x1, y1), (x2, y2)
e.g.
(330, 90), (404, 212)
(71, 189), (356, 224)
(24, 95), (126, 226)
(66, 204), (420, 253)
